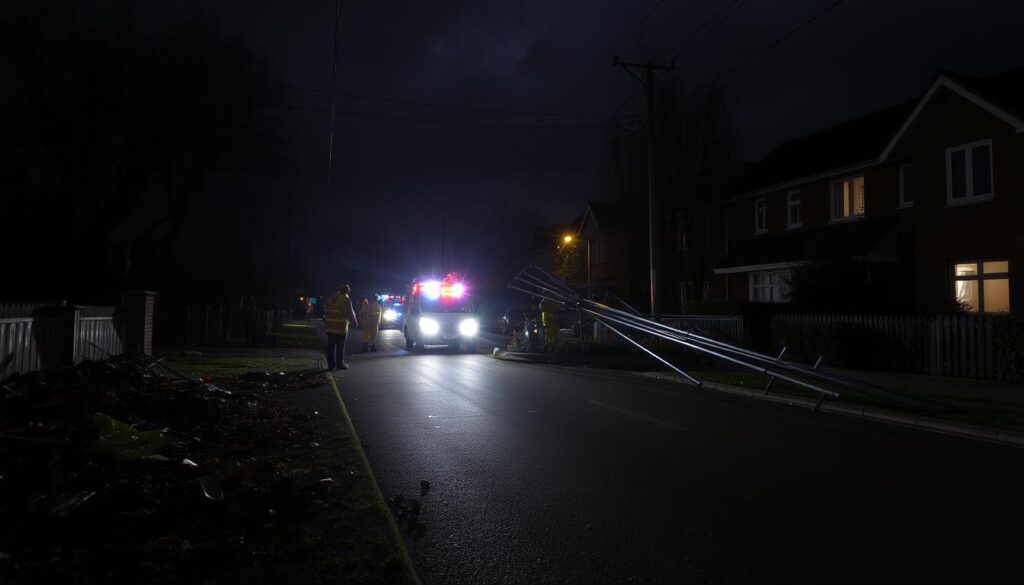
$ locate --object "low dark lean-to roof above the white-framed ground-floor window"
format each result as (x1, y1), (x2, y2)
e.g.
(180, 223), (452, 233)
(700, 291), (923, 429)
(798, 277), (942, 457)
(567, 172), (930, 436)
(715, 216), (898, 274)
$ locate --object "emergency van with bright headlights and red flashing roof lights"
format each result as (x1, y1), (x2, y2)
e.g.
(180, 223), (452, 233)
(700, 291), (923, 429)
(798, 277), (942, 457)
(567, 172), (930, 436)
(402, 273), (480, 351)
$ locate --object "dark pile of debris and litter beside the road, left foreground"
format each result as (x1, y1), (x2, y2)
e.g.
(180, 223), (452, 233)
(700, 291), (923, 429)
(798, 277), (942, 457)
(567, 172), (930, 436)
(0, 356), (329, 583)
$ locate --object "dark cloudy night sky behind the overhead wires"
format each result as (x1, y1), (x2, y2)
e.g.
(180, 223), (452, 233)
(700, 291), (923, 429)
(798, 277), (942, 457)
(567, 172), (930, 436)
(12, 0), (1024, 297)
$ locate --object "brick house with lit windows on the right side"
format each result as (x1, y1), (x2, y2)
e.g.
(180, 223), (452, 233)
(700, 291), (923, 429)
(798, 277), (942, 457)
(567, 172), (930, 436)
(692, 68), (1024, 314)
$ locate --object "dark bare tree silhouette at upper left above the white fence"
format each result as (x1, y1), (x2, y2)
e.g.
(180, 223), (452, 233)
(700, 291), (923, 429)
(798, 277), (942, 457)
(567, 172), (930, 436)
(0, 0), (280, 295)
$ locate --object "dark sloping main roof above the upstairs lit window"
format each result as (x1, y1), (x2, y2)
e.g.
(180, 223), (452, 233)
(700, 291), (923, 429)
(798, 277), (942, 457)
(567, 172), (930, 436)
(739, 101), (915, 192)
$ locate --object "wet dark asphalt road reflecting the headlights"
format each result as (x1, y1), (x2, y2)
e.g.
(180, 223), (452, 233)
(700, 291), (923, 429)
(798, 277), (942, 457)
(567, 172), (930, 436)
(337, 331), (1024, 584)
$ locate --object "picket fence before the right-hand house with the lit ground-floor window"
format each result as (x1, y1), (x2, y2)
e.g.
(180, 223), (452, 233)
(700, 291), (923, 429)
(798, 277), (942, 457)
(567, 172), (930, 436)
(771, 315), (1022, 380)
